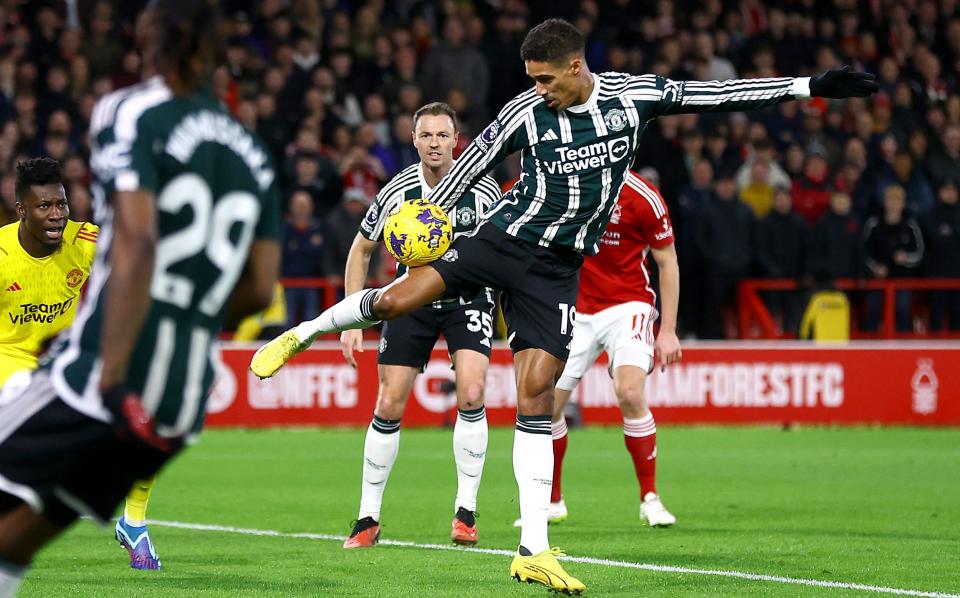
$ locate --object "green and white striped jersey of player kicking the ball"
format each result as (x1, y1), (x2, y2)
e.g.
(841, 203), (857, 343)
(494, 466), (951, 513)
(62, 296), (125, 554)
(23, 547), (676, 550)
(429, 73), (810, 255)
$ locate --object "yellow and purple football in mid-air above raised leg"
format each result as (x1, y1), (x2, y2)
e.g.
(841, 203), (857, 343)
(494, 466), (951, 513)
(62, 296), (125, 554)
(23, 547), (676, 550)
(383, 199), (453, 266)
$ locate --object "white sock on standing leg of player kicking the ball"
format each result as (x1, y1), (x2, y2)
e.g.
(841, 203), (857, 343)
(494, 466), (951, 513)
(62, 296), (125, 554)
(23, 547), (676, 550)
(513, 415), (553, 554)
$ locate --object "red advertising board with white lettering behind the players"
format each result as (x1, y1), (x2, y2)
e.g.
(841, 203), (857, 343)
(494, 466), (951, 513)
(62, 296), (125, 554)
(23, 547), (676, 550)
(207, 341), (960, 427)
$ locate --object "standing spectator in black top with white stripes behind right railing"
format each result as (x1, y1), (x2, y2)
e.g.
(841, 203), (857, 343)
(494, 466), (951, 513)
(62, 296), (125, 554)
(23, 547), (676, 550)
(863, 185), (924, 332)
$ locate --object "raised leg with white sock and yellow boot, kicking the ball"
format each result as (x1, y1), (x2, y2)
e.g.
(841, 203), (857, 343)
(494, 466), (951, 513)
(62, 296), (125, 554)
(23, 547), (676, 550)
(250, 266), (446, 378)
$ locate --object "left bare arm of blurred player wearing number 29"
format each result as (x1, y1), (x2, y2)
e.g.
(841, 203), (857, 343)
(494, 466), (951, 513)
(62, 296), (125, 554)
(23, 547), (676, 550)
(100, 189), (157, 390)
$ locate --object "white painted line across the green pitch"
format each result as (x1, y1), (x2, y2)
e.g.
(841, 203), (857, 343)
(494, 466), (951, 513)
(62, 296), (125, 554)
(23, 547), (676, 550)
(150, 519), (960, 598)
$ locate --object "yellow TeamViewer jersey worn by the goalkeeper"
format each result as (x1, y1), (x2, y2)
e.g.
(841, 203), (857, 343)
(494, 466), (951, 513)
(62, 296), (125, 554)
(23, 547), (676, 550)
(0, 220), (100, 386)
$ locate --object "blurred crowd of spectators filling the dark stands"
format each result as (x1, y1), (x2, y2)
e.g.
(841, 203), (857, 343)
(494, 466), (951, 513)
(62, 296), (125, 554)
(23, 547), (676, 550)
(0, 0), (960, 338)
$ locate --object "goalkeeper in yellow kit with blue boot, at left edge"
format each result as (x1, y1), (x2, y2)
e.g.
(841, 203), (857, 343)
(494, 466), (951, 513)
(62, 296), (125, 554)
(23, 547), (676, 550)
(0, 158), (160, 569)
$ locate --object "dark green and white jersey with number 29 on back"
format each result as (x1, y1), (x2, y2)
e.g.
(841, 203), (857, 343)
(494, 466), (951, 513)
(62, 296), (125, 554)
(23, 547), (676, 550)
(50, 77), (280, 436)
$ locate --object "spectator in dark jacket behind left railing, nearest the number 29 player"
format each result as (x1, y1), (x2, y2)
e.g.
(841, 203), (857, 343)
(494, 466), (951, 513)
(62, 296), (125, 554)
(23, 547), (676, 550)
(282, 191), (324, 326)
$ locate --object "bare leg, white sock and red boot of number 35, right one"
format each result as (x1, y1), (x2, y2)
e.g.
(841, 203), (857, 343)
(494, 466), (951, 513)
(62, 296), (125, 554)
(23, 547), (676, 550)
(450, 350), (490, 545)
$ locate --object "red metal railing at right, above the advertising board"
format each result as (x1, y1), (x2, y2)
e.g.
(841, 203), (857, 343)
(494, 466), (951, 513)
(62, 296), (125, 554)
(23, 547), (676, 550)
(737, 278), (960, 339)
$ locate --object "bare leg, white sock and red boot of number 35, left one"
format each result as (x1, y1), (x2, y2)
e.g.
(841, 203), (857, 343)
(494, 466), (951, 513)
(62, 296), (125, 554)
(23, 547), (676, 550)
(343, 365), (417, 548)
